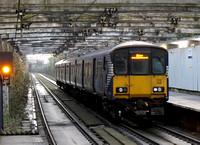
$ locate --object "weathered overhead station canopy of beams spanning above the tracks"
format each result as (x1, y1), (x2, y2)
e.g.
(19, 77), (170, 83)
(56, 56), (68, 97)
(0, 0), (200, 56)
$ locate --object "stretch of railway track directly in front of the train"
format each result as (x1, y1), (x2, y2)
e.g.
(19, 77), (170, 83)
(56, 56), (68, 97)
(120, 119), (200, 145)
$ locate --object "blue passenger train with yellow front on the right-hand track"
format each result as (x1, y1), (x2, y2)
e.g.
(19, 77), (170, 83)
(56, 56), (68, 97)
(55, 41), (169, 118)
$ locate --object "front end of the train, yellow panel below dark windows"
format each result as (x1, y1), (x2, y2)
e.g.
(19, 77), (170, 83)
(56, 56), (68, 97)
(109, 43), (168, 115)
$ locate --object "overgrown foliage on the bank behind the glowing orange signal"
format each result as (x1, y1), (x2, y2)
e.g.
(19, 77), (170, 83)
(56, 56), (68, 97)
(4, 53), (29, 131)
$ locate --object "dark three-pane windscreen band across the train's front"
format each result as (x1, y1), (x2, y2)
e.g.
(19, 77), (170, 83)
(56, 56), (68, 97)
(114, 48), (167, 75)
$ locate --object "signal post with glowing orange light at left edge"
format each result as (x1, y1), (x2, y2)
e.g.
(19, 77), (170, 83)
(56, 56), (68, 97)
(0, 52), (13, 134)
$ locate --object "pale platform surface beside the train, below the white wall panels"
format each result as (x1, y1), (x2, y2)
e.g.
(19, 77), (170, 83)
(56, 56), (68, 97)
(167, 91), (200, 112)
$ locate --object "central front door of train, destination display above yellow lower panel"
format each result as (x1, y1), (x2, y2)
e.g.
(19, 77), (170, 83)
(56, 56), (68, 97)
(129, 50), (152, 98)
